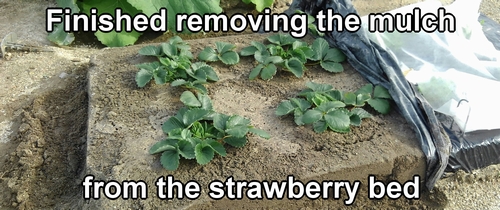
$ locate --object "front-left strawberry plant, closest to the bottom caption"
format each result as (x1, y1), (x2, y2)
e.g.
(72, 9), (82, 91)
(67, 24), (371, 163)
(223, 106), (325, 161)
(149, 91), (270, 171)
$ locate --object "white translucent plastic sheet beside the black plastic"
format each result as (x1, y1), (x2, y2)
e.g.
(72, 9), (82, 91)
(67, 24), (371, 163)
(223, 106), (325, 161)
(362, 0), (500, 132)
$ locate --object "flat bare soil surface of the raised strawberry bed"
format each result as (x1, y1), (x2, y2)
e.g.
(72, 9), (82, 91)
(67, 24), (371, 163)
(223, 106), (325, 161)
(85, 34), (430, 209)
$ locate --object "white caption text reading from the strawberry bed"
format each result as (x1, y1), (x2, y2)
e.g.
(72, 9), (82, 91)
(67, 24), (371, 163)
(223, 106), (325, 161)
(82, 175), (420, 205)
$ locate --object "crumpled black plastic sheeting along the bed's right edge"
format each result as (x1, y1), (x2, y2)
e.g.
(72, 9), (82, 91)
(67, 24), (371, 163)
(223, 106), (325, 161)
(287, 0), (500, 190)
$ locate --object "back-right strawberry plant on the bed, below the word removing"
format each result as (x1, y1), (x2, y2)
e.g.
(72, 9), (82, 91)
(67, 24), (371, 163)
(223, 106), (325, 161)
(240, 33), (346, 80)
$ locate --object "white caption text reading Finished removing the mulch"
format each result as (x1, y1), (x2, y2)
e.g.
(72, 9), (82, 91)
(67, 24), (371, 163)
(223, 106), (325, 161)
(46, 8), (456, 38)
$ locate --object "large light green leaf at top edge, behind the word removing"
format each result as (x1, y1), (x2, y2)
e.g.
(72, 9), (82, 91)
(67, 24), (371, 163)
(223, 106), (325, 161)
(128, 0), (222, 31)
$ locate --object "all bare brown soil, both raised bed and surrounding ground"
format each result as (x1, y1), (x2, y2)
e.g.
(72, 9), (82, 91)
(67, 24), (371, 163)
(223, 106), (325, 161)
(0, 0), (500, 209)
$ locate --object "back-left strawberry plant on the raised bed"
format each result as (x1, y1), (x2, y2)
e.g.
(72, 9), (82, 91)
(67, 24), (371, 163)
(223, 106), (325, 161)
(135, 36), (219, 93)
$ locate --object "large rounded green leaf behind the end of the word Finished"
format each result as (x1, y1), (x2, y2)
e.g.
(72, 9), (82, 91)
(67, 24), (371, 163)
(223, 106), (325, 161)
(81, 0), (141, 47)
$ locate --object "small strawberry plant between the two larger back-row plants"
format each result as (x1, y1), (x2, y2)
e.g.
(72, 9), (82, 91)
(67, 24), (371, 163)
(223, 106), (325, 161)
(198, 42), (240, 65)
